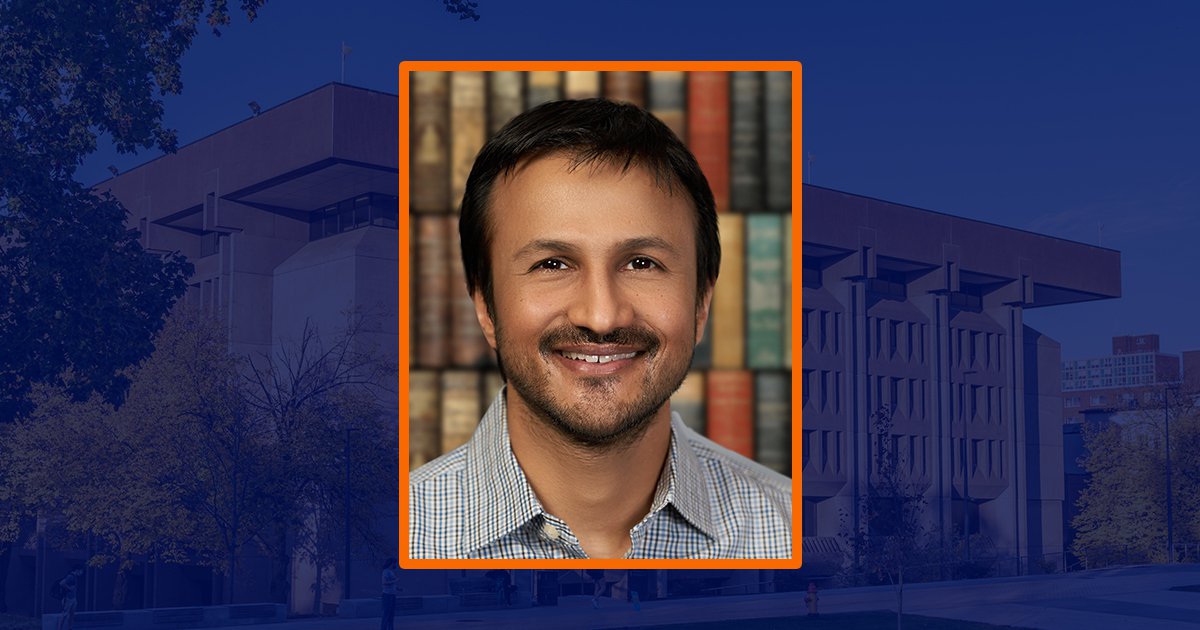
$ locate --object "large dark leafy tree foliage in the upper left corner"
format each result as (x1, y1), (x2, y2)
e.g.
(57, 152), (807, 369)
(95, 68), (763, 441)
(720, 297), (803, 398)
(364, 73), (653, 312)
(0, 0), (264, 421)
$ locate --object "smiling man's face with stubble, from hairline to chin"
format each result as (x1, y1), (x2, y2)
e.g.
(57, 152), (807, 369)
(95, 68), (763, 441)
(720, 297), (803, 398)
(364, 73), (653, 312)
(475, 155), (708, 446)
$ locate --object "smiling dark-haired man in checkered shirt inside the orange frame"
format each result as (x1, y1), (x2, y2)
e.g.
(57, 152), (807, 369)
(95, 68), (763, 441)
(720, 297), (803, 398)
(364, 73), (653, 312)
(409, 98), (792, 558)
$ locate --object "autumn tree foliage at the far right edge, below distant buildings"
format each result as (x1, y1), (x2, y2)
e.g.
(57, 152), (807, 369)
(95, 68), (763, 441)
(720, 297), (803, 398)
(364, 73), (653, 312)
(1072, 391), (1200, 566)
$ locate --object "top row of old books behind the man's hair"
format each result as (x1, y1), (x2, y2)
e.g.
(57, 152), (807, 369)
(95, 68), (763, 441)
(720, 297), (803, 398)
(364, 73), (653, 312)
(409, 71), (792, 214)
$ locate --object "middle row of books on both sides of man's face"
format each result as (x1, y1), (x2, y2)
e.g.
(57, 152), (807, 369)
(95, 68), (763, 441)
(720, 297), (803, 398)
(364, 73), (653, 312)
(409, 214), (792, 370)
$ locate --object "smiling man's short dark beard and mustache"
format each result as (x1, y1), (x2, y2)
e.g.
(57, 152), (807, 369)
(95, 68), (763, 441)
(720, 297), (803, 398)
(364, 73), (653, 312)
(496, 322), (695, 451)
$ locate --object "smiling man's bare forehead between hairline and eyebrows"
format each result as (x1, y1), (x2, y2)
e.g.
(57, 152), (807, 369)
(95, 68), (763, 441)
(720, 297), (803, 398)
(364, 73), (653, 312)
(490, 154), (696, 251)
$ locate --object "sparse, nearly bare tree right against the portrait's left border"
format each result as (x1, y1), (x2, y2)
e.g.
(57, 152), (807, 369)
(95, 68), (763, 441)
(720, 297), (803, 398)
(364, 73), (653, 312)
(240, 312), (398, 598)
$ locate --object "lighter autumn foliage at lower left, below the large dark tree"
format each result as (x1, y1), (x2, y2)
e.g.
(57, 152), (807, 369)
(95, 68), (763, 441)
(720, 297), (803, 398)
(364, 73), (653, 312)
(0, 307), (395, 607)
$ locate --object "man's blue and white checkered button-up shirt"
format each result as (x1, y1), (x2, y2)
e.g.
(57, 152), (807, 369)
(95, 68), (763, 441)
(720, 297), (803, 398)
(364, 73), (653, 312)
(408, 390), (792, 559)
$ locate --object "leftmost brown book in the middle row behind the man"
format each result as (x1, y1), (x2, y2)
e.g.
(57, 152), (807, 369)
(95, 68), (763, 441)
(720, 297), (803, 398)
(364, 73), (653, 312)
(410, 215), (451, 367)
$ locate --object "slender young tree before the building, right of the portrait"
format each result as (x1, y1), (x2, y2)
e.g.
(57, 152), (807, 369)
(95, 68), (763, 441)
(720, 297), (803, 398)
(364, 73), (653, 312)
(841, 406), (942, 630)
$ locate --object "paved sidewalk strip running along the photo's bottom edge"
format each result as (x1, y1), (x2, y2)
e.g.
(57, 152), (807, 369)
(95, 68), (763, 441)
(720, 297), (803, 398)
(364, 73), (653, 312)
(258, 565), (1200, 630)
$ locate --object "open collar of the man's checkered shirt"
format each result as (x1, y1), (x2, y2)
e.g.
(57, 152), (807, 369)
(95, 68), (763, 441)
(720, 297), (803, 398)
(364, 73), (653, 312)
(460, 385), (718, 558)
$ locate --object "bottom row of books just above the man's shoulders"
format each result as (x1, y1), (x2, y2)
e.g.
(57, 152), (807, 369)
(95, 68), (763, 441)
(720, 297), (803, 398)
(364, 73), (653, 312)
(408, 370), (792, 475)
